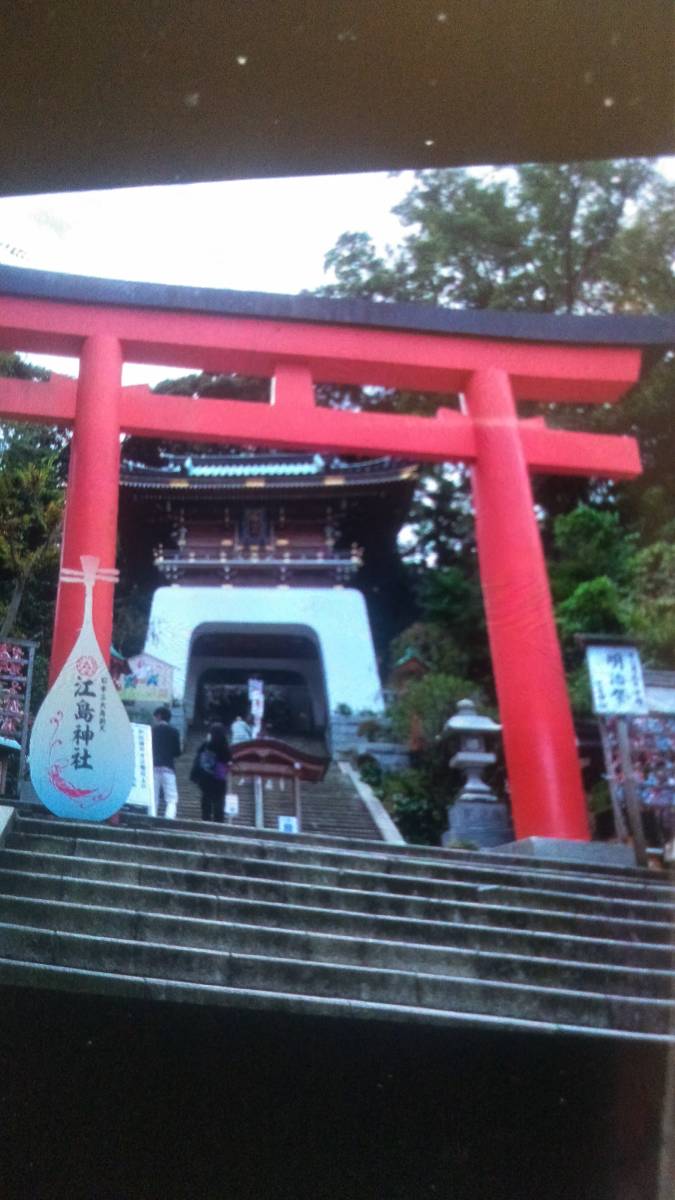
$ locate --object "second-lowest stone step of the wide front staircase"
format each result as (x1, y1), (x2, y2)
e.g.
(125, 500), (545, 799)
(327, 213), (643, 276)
(0, 894), (675, 1015)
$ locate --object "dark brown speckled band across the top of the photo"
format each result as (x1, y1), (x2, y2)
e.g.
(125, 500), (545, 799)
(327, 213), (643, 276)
(0, 0), (673, 194)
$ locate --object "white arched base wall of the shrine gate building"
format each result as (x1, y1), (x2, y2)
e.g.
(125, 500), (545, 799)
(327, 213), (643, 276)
(145, 587), (383, 713)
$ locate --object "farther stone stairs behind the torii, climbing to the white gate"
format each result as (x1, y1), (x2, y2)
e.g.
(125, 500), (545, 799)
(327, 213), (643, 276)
(170, 731), (381, 839)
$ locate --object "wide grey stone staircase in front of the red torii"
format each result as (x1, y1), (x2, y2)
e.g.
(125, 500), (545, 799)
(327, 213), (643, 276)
(0, 810), (675, 1040)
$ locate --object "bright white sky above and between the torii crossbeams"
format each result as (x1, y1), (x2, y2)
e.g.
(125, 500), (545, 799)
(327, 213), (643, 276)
(0, 157), (675, 384)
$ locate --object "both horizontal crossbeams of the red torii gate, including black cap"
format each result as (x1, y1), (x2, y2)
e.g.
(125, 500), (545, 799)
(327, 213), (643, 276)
(0, 268), (673, 478)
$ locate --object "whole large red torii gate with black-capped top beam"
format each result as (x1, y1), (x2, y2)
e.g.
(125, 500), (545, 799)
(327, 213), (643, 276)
(0, 268), (667, 839)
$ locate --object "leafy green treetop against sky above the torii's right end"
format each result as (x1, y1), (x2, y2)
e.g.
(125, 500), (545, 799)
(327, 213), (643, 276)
(323, 161), (675, 312)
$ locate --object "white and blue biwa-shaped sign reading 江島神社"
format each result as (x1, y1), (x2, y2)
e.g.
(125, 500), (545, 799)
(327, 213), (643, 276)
(30, 554), (135, 821)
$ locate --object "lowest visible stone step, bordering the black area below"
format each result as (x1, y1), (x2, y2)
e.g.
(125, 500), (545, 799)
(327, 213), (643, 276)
(0, 924), (675, 1037)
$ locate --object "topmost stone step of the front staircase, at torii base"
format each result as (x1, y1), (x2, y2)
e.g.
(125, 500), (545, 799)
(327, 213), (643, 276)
(7, 816), (675, 910)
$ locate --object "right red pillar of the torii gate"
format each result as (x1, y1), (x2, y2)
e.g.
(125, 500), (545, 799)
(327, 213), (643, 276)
(466, 370), (589, 839)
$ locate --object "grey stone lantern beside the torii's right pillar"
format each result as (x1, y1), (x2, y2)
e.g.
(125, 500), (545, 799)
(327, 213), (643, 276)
(441, 700), (513, 846)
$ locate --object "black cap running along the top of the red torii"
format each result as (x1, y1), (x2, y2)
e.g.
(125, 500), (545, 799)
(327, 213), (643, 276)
(0, 265), (675, 358)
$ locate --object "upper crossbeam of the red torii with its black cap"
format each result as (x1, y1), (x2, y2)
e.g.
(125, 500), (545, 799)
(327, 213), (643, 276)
(0, 268), (674, 403)
